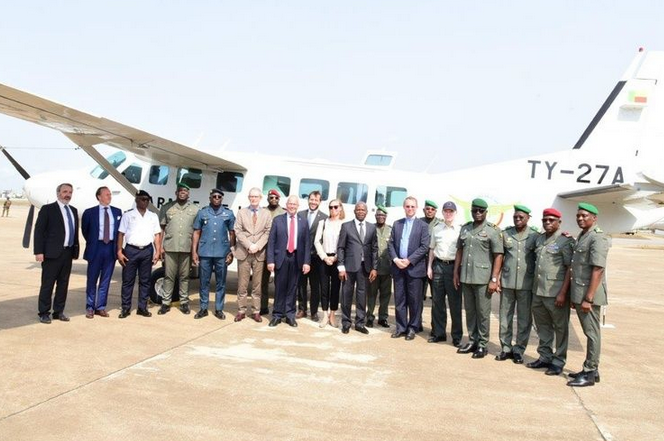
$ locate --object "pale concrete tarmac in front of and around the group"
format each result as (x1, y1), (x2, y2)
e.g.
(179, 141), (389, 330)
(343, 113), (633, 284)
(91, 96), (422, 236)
(0, 204), (664, 441)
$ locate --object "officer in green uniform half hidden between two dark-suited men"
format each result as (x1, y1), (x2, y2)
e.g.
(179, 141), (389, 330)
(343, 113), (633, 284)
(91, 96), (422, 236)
(367, 205), (392, 328)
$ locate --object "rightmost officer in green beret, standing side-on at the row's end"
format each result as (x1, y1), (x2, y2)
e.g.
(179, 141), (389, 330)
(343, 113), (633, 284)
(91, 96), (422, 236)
(567, 203), (611, 387)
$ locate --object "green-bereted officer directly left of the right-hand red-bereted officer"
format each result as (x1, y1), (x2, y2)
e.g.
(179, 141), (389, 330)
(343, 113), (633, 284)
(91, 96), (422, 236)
(496, 205), (538, 364)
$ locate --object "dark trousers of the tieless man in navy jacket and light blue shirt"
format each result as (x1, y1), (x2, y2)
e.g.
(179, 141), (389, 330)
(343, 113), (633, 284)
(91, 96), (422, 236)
(393, 270), (422, 333)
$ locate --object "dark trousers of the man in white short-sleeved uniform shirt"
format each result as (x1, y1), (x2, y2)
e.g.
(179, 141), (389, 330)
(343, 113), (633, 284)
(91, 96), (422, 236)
(122, 244), (154, 309)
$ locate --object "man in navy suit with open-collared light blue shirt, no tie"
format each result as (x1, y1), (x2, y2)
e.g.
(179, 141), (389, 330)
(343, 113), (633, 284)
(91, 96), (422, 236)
(387, 196), (429, 340)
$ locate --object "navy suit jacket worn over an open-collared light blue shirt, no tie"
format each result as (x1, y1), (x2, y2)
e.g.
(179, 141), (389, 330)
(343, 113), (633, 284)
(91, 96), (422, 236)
(387, 218), (430, 277)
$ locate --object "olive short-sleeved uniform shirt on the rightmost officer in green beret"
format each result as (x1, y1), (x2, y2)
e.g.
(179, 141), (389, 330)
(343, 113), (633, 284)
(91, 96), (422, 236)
(570, 226), (611, 306)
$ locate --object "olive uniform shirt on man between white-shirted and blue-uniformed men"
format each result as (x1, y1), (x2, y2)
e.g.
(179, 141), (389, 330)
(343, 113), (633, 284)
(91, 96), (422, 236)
(159, 201), (198, 253)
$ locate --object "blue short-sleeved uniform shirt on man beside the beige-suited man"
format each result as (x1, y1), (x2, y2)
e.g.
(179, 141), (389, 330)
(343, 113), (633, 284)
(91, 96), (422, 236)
(194, 205), (235, 257)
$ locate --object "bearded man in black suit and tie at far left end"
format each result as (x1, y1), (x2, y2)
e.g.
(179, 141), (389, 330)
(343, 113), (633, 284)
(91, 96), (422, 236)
(34, 183), (79, 324)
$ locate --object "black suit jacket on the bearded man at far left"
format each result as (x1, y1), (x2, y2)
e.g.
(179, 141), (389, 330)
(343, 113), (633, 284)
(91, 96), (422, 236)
(34, 201), (79, 259)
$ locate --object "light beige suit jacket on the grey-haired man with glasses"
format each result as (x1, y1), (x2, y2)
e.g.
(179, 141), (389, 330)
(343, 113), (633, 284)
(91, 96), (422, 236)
(235, 207), (272, 262)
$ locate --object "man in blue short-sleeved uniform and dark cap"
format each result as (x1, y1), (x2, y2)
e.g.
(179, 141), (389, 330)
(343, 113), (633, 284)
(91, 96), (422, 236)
(191, 188), (235, 320)
